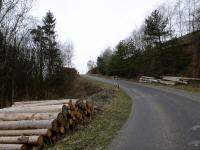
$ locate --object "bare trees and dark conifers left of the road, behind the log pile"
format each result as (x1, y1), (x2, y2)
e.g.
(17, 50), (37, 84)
(0, 0), (78, 107)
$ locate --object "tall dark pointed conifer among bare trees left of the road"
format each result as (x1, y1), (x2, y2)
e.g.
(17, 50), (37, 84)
(31, 11), (63, 96)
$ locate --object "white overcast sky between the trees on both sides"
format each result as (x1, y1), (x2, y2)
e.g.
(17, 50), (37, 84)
(31, 0), (165, 73)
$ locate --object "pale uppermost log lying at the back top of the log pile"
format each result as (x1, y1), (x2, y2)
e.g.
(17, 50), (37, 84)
(13, 99), (78, 106)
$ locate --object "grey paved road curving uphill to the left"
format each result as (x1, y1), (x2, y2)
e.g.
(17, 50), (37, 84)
(85, 77), (200, 150)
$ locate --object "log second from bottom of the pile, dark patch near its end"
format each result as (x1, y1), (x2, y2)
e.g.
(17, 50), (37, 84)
(0, 136), (43, 145)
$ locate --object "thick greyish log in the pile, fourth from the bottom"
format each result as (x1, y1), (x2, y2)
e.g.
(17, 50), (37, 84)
(0, 120), (54, 130)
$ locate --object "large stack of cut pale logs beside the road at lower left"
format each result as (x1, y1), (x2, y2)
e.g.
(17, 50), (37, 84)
(0, 99), (93, 150)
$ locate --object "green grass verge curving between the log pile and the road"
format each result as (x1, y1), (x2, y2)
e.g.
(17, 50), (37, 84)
(47, 82), (132, 150)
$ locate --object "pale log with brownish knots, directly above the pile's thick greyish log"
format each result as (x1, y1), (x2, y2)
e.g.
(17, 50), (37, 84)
(0, 113), (59, 121)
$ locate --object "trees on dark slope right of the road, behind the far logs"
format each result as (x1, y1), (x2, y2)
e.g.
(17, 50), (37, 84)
(88, 0), (200, 77)
